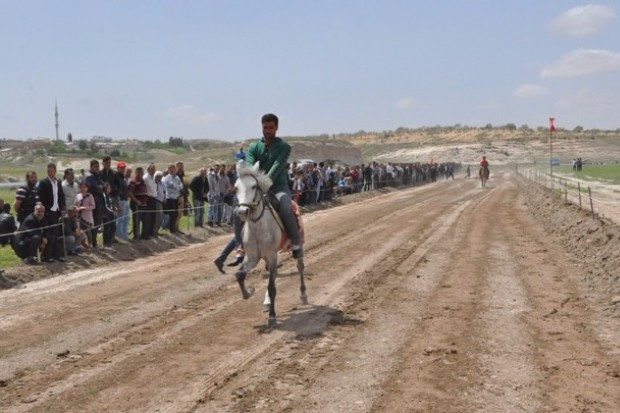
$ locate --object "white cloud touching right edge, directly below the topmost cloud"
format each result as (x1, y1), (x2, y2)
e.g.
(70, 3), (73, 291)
(540, 49), (620, 78)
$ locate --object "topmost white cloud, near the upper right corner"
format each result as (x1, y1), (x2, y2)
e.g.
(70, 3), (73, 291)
(549, 4), (616, 36)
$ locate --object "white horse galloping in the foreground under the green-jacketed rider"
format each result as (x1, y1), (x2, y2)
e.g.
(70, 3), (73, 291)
(235, 162), (308, 327)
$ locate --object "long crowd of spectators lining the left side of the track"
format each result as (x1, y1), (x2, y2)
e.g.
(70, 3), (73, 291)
(0, 153), (458, 265)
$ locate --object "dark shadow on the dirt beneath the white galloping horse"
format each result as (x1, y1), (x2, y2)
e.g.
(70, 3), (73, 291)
(254, 305), (363, 334)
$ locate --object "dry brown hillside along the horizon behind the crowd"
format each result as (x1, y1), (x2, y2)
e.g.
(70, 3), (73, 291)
(0, 127), (620, 181)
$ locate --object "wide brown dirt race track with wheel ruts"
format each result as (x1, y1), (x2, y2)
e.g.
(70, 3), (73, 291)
(0, 172), (620, 413)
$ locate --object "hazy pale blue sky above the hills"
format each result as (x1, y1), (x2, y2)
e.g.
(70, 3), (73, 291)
(0, 0), (620, 141)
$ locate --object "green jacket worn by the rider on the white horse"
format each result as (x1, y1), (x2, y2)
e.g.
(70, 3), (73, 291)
(245, 137), (291, 186)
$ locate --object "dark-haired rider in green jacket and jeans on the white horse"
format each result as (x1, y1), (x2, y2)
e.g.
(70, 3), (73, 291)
(246, 113), (303, 258)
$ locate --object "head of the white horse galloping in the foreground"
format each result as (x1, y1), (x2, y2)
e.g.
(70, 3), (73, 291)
(235, 161), (272, 221)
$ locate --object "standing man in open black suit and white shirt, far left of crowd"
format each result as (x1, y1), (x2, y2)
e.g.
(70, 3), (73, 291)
(39, 163), (67, 262)
